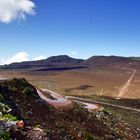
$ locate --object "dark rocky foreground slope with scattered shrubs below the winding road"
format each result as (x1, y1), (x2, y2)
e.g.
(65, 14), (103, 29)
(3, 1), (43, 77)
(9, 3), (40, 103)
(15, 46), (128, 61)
(0, 79), (140, 140)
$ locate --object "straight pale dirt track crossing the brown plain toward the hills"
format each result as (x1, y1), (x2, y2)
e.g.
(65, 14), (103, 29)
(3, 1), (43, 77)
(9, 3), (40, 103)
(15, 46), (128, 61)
(116, 69), (137, 99)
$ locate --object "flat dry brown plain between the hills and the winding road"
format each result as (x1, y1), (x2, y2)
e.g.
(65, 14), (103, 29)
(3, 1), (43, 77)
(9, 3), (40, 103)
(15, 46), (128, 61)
(0, 68), (140, 98)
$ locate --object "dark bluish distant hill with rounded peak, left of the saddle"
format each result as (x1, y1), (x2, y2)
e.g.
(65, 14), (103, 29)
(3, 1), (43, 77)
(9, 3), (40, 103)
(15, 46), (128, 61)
(1, 55), (83, 69)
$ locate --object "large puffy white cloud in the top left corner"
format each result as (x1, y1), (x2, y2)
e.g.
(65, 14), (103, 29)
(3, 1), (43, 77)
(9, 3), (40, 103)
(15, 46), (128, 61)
(0, 0), (35, 23)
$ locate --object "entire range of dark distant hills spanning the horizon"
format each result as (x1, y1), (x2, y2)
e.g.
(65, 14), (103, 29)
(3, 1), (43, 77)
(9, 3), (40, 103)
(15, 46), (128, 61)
(0, 55), (140, 71)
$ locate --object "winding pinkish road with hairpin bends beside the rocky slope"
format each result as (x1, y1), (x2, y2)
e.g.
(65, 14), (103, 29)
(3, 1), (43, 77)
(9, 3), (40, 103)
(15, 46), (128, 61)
(37, 89), (140, 112)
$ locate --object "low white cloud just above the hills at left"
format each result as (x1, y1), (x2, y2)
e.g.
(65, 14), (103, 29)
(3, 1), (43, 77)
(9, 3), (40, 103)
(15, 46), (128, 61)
(0, 52), (46, 65)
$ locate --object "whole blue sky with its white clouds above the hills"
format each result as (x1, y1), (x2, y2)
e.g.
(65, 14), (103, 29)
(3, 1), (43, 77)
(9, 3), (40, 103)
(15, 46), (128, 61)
(0, 0), (140, 64)
